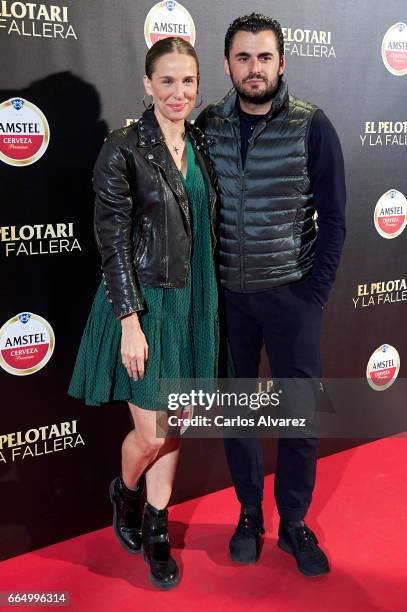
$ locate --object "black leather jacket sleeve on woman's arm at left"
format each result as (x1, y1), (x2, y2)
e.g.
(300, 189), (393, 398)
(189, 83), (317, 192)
(93, 130), (143, 319)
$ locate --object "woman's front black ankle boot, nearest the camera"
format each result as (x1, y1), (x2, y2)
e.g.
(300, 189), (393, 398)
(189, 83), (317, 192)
(141, 502), (179, 589)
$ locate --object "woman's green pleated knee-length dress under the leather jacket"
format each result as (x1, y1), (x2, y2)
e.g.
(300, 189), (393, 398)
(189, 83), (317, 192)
(68, 140), (219, 410)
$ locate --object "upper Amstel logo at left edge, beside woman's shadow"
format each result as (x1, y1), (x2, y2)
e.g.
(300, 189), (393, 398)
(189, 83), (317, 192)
(0, 98), (49, 166)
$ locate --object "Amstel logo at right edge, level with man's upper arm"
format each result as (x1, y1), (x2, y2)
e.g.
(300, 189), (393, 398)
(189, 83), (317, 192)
(374, 189), (407, 238)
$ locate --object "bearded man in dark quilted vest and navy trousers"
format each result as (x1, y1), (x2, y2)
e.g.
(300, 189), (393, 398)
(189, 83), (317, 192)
(196, 13), (346, 576)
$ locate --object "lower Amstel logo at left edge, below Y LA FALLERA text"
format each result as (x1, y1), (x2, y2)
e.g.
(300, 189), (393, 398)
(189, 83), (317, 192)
(0, 312), (55, 376)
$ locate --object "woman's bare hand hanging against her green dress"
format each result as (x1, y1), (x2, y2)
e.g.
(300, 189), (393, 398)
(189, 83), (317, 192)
(120, 312), (148, 380)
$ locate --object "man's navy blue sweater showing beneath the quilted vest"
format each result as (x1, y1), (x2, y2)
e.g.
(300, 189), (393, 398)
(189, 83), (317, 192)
(237, 104), (346, 305)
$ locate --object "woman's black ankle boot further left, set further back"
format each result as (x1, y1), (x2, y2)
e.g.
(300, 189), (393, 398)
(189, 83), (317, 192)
(109, 474), (145, 555)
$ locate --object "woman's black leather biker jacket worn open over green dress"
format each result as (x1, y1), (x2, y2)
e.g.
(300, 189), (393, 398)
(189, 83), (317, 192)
(94, 110), (216, 318)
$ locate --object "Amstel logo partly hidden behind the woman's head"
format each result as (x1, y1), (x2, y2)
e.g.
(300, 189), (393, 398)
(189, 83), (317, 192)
(144, 0), (196, 48)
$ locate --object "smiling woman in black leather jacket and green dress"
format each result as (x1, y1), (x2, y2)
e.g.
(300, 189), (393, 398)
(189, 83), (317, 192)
(69, 37), (218, 588)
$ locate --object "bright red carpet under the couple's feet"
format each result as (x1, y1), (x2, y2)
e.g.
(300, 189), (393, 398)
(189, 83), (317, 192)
(0, 438), (407, 612)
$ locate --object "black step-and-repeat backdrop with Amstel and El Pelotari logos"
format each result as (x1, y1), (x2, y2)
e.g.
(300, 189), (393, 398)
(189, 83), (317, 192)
(0, 0), (407, 558)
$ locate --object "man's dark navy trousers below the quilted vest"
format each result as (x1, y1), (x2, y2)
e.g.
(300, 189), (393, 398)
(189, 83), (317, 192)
(224, 279), (322, 521)
